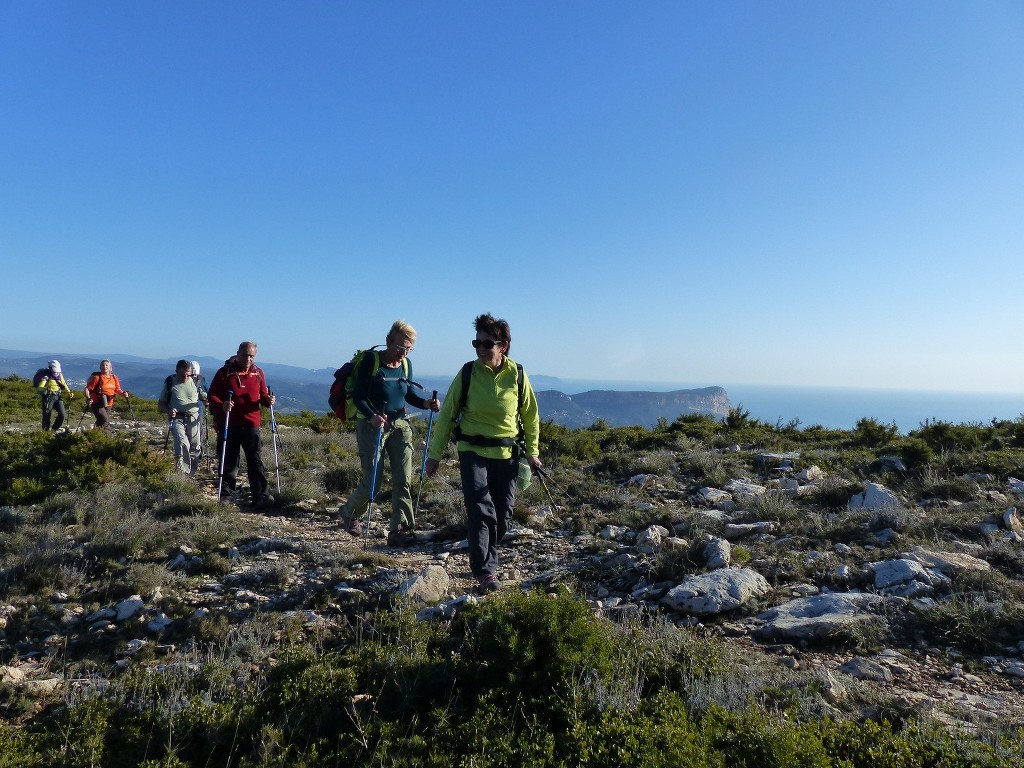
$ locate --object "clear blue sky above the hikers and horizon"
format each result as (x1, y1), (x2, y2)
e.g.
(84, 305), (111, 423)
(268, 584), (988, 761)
(0, 0), (1024, 392)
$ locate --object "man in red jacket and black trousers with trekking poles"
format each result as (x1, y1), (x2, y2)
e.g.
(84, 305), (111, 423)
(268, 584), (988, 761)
(208, 341), (276, 507)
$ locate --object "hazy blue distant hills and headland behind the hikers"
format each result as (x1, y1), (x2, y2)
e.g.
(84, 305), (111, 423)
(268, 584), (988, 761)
(0, 349), (732, 428)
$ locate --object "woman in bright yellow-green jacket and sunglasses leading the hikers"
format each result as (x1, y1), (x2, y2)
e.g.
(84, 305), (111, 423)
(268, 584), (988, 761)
(426, 314), (543, 592)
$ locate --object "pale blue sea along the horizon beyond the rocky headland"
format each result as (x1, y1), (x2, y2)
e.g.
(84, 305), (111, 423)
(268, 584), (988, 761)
(540, 379), (1024, 434)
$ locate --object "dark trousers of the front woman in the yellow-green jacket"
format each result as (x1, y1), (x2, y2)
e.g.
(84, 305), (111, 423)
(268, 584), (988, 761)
(459, 451), (518, 579)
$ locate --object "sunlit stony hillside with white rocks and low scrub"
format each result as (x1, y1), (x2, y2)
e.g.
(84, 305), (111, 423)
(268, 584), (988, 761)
(0, 391), (1024, 765)
